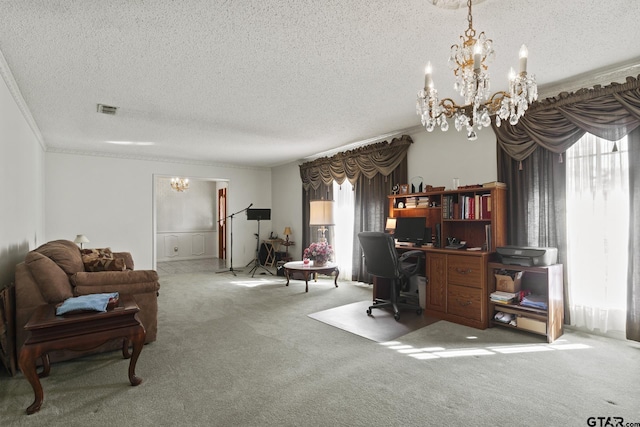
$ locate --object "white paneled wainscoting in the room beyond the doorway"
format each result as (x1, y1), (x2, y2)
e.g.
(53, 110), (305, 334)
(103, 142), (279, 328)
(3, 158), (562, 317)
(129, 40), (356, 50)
(156, 231), (218, 262)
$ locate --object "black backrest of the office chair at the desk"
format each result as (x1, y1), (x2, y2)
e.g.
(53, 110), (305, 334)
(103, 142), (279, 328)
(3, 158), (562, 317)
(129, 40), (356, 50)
(358, 231), (400, 279)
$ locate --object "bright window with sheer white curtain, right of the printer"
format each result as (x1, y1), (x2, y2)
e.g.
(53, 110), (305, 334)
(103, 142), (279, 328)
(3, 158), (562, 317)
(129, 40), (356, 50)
(566, 134), (629, 333)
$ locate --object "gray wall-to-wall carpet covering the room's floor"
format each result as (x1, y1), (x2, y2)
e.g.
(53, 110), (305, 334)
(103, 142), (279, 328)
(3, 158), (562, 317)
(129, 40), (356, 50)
(0, 272), (640, 427)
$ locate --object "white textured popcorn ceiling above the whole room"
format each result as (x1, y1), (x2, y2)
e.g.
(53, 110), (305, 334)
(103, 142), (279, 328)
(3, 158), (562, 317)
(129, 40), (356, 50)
(0, 0), (640, 166)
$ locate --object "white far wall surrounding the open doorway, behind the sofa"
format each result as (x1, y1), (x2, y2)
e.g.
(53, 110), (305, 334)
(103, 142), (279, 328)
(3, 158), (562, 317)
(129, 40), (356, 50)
(45, 152), (271, 269)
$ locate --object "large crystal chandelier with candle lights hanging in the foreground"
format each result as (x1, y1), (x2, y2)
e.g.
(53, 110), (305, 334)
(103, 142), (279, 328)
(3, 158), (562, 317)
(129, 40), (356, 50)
(416, 0), (538, 141)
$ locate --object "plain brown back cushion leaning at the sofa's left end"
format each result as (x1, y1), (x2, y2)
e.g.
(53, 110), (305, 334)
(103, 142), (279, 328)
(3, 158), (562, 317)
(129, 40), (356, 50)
(24, 251), (73, 304)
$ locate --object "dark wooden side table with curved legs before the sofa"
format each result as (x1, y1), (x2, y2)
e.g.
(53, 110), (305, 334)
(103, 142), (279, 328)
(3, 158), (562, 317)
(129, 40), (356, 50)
(18, 295), (146, 414)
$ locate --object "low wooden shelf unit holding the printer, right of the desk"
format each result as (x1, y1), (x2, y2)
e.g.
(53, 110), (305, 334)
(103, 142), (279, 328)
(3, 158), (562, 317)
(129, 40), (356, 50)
(487, 262), (564, 343)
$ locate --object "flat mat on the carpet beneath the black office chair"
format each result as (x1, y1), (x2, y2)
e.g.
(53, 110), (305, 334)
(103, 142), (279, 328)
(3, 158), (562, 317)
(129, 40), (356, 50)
(308, 301), (438, 342)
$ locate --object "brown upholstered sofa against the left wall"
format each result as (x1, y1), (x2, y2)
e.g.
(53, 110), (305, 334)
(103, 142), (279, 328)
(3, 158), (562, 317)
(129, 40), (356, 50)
(15, 240), (160, 362)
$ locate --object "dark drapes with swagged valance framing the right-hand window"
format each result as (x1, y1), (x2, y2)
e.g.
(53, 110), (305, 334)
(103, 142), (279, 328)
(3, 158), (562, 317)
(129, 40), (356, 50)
(493, 77), (640, 340)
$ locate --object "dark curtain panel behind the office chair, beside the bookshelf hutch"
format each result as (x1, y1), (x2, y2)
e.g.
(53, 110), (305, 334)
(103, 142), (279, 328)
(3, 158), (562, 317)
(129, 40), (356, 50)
(352, 163), (408, 283)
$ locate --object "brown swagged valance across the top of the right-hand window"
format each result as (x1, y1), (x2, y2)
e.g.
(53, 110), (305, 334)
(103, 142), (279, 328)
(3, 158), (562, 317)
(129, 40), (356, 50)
(492, 76), (640, 160)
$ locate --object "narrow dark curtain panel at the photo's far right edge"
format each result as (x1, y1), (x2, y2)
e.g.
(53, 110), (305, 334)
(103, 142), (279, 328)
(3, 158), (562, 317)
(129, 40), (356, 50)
(626, 128), (640, 341)
